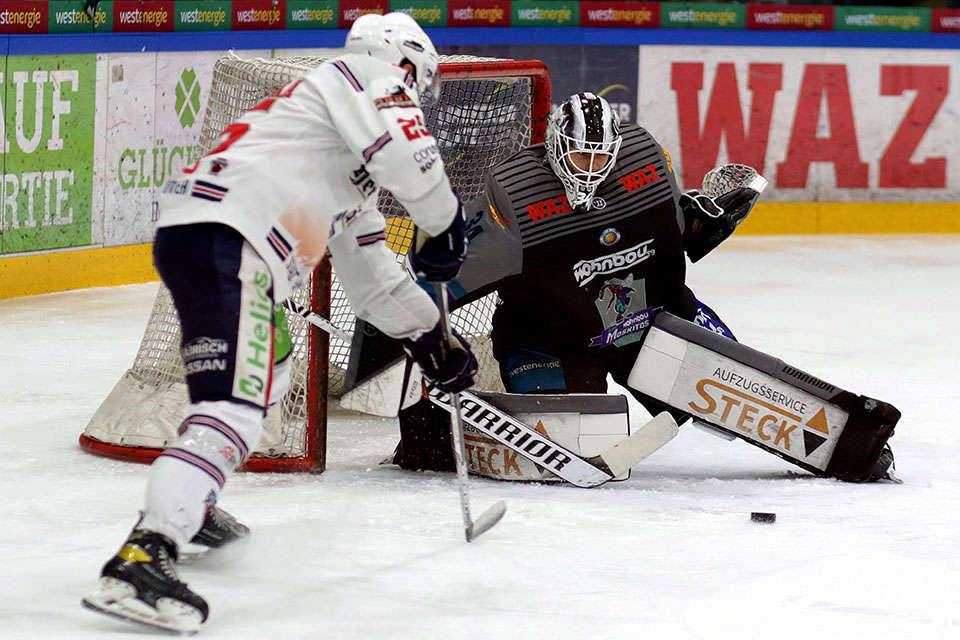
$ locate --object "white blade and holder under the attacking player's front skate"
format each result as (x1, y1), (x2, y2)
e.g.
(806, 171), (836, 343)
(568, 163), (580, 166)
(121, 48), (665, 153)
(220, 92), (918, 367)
(81, 578), (203, 635)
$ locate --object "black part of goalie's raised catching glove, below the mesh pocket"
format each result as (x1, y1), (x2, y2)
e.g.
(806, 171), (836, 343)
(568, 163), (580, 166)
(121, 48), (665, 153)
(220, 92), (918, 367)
(680, 187), (760, 262)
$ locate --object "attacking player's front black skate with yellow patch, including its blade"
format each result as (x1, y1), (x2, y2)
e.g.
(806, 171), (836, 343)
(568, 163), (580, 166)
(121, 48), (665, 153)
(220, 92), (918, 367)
(83, 529), (209, 633)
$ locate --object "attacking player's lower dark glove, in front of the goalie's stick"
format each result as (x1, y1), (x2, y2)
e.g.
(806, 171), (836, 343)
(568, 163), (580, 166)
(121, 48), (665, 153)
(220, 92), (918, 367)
(401, 323), (478, 393)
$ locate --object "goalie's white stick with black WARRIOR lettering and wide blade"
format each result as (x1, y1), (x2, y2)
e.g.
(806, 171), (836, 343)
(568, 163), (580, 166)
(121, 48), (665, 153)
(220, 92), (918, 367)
(282, 305), (677, 488)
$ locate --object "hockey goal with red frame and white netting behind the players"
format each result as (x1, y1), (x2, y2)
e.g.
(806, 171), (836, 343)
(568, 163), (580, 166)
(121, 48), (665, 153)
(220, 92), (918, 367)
(80, 54), (550, 472)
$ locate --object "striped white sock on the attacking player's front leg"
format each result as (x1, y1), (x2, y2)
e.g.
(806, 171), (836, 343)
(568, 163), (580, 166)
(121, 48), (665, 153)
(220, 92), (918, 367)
(139, 401), (263, 546)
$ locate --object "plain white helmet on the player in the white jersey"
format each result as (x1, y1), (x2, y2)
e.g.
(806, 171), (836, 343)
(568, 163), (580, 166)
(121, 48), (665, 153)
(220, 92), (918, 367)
(344, 11), (440, 101)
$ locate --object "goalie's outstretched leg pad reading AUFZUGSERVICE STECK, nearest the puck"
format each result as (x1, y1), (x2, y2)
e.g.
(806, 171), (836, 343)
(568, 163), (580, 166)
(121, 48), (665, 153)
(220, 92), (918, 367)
(628, 313), (900, 482)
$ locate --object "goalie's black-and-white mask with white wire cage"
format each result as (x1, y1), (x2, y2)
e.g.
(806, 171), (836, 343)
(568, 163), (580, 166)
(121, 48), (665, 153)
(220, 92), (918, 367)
(546, 93), (622, 209)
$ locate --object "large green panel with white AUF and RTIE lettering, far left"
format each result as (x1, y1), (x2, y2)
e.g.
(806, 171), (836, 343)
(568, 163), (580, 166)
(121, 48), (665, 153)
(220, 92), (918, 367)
(0, 54), (96, 253)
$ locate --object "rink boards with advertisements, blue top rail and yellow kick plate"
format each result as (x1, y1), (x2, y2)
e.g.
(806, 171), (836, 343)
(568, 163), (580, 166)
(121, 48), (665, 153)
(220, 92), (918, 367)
(0, 28), (960, 298)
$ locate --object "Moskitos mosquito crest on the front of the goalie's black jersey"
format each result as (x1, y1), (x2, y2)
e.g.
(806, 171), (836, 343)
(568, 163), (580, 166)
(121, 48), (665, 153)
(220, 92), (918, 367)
(590, 273), (659, 347)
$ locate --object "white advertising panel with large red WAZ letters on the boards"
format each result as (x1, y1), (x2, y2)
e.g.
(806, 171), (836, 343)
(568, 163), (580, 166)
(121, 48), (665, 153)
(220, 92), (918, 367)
(637, 46), (960, 202)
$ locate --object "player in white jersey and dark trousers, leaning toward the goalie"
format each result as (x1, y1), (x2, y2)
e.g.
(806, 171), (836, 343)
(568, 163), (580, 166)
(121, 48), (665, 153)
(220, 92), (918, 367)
(83, 13), (476, 632)
